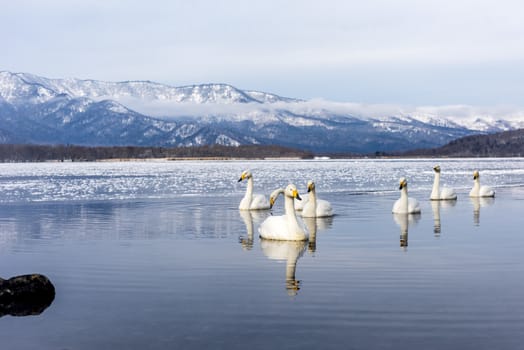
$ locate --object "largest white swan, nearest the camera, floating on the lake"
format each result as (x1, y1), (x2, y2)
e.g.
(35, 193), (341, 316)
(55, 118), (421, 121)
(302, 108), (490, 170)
(258, 184), (308, 241)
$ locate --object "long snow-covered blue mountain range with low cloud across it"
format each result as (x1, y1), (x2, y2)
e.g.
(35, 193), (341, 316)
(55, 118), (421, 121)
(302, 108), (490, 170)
(0, 71), (524, 153)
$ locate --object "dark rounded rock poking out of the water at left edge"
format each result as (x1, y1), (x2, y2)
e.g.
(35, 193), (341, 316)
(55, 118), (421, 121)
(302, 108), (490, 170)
(0, 274), (55, 317)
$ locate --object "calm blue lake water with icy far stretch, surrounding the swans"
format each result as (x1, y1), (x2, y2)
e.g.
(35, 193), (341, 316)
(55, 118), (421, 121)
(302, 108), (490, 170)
(0, 159), (524, 349)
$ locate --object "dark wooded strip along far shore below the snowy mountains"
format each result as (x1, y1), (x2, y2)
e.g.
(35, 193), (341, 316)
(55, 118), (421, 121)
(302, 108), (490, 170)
(0, 129), (524, 162)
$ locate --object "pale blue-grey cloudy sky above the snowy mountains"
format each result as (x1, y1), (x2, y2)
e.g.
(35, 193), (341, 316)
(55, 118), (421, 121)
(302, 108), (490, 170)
(0, 0), (524, 107)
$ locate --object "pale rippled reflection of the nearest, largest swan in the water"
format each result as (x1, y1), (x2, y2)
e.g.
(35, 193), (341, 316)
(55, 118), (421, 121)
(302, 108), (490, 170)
(260, 239), (308, 296)
